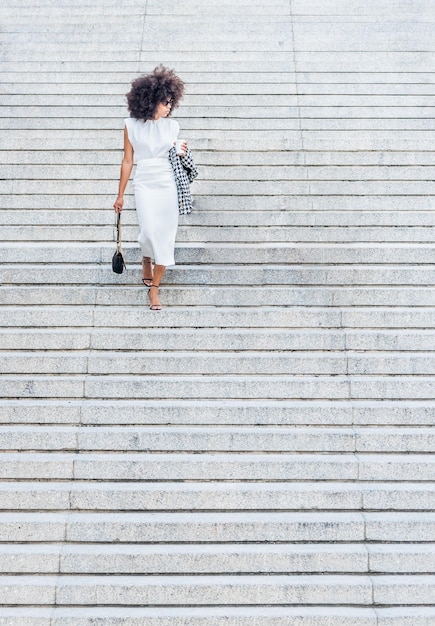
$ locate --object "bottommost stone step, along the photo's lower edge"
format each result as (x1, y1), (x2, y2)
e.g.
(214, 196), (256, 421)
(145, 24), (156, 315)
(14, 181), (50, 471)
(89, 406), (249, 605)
(0, 606), (433, 626)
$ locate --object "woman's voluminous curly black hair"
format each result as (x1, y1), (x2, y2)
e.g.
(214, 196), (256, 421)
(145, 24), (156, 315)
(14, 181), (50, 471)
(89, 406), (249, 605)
(127, 65), (184, 121)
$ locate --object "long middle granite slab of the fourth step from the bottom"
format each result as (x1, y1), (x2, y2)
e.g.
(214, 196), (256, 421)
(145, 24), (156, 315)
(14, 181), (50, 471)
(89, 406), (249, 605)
(63, 512), (364, 543)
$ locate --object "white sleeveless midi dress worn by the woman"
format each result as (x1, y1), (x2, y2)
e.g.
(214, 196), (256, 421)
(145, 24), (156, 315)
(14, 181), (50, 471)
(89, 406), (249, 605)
(125, 117), (180, 266)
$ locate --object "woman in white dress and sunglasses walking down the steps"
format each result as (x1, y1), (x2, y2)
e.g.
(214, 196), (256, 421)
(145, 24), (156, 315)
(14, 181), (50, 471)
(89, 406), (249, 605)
(113, 65), (187, 311)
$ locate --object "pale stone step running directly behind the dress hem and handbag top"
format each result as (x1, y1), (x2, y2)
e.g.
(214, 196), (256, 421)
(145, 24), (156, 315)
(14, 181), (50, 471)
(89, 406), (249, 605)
(0, 243), (435, 269)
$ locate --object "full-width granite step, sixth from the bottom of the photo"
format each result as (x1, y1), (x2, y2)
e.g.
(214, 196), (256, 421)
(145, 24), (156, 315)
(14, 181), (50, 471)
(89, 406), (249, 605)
(0, 448), (434, 480)
